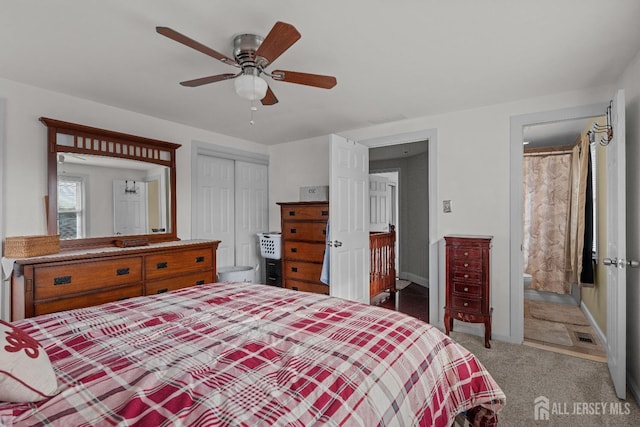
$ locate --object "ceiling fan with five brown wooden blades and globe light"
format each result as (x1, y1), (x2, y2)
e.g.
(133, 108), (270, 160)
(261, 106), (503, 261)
(156, 22), (337, 105)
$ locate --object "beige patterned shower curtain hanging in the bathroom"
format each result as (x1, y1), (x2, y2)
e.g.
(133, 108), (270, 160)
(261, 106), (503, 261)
(523, 137), (589, 294)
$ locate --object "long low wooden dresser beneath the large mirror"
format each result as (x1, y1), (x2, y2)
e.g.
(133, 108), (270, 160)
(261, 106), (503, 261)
(11, 240), (219, 320)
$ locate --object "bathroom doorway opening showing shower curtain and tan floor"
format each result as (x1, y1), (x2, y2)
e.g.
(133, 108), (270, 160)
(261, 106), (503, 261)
(522, 116), (606, 362)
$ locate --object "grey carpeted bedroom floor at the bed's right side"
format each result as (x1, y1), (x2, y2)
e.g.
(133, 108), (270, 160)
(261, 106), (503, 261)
(451, 331), (640, 427)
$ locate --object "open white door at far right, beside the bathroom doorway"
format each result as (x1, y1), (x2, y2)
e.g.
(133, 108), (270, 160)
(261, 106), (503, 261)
(602, 90), (627, 399)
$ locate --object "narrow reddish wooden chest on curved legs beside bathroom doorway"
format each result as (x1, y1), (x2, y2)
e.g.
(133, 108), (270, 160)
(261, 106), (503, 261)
(444, 236), (493, 348)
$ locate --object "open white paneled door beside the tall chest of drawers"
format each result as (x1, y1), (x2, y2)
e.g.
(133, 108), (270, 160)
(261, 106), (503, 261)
(329, 135), (369, 304)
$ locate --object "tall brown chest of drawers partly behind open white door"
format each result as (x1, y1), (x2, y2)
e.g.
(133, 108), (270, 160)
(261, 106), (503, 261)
(278, 202), (329, 295)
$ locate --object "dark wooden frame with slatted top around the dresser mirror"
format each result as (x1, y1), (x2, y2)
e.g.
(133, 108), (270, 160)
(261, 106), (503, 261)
(40, 117), (181, 251)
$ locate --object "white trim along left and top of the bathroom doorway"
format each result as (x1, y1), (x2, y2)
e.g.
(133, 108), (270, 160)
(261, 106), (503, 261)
(508, 101), (609, 344)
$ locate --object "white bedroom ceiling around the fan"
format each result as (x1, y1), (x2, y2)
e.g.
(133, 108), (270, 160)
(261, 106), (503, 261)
(0, 0), (640, 144)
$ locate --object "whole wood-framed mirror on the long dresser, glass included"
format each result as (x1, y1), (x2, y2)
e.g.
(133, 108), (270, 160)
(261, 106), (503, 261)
(40, 117), (180, 250)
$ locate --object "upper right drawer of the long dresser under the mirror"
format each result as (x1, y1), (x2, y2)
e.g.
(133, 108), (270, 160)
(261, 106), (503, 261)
(145, 249), (213, 280)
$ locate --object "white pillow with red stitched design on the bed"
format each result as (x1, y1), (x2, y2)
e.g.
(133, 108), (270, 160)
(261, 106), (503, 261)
(0, 320), (58, 402)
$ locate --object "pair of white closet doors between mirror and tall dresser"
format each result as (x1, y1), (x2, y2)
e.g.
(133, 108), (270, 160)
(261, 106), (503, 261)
(194, 154), (269, 277)
